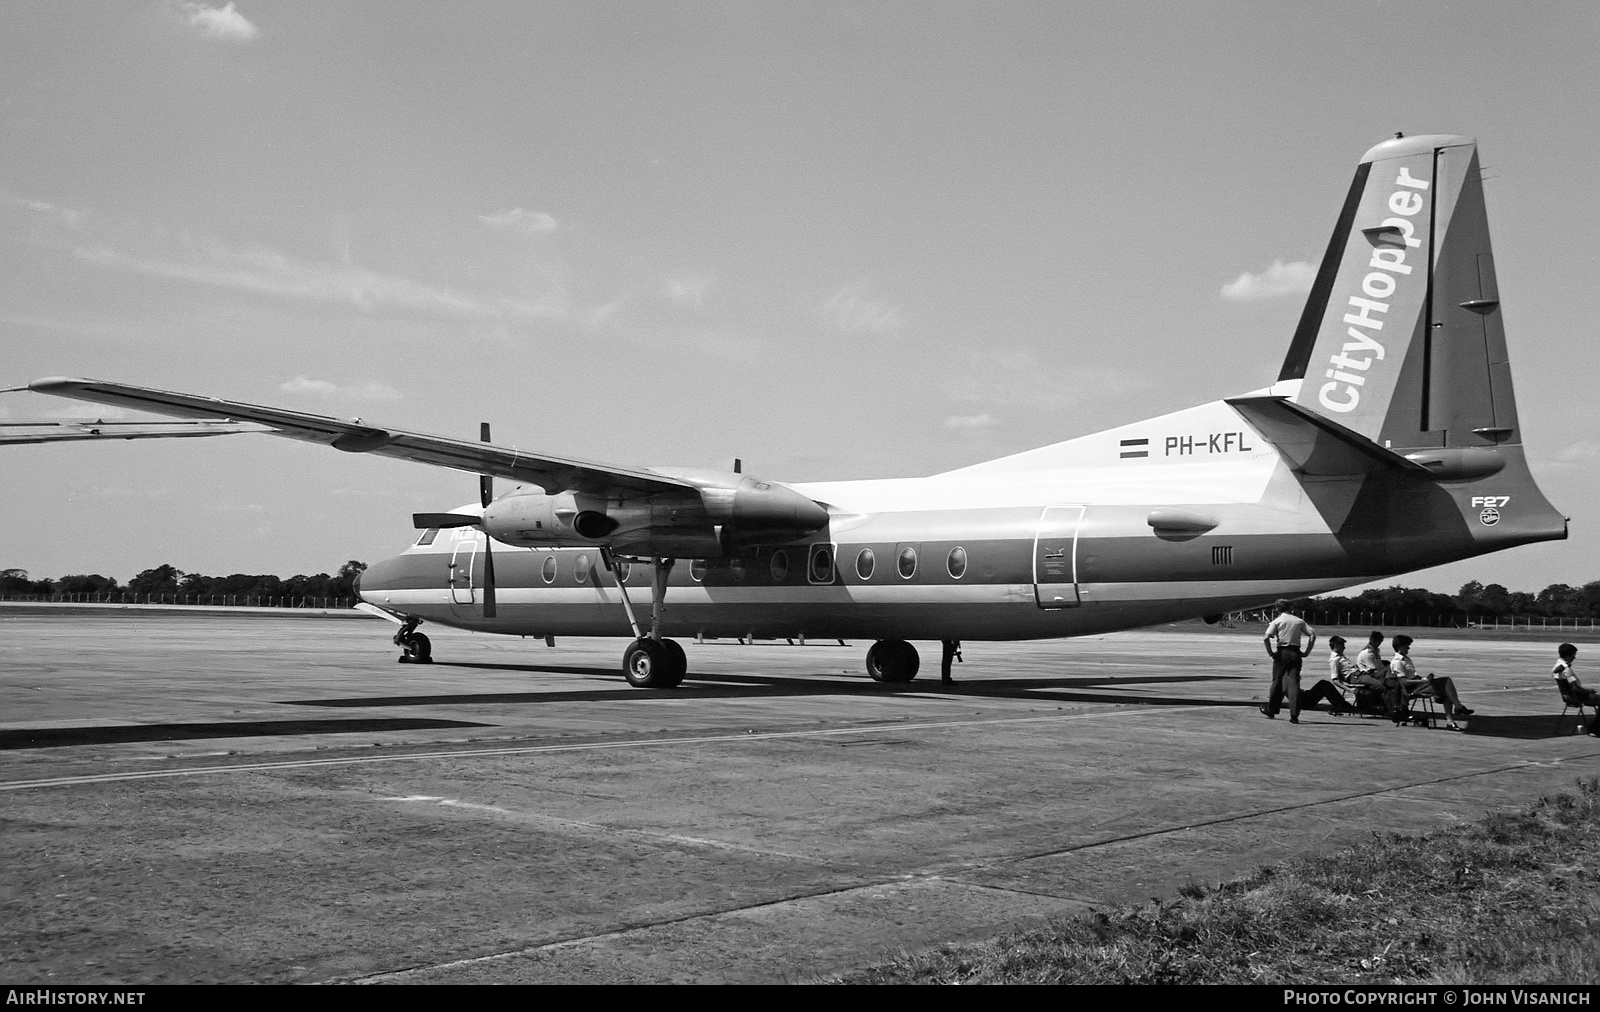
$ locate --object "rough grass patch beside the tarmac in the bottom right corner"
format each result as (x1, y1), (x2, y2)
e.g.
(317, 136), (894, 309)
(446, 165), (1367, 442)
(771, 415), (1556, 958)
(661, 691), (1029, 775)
(843, 778), (1600, 985)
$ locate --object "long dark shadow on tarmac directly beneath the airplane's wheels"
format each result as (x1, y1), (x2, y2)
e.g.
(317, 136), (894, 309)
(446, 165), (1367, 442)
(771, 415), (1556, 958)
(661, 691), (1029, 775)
(280, 663), (1259, 708)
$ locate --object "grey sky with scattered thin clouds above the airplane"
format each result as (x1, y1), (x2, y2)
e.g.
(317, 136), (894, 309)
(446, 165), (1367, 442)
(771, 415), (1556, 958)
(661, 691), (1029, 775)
(0, 0), (1600, 591)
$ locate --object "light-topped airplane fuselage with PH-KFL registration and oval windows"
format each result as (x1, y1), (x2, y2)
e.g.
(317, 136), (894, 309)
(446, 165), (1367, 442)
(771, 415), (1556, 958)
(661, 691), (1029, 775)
(362, 395), (1565, 639)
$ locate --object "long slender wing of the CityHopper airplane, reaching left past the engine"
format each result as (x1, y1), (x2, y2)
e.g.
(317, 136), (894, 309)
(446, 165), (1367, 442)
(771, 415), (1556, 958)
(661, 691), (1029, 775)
(18, 376), (698, 496)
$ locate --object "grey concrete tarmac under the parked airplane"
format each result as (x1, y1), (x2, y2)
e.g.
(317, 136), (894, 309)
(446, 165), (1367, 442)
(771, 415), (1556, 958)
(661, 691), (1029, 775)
(0, 605), (1600, 983)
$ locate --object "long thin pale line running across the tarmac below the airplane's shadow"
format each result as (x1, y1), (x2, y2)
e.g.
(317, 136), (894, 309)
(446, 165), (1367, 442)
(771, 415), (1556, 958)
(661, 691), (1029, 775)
(0, 706), (1214, 791)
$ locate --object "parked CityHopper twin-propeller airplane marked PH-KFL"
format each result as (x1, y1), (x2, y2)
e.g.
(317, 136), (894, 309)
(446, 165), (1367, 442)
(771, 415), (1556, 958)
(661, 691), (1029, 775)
(9, 135), (1566, 689)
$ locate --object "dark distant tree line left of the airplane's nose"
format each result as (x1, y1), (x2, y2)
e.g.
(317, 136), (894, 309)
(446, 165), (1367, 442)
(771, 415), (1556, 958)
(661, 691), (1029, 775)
(0, 559), (366, 607)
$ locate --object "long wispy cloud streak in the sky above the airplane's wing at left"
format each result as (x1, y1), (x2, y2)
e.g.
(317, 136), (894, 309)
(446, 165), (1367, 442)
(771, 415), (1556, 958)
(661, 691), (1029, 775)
(74, 240), (568, 320)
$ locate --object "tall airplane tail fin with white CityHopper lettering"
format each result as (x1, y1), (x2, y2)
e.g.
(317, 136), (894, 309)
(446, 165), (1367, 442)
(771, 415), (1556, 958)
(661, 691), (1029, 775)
(1278, 135), (1522, 452)
